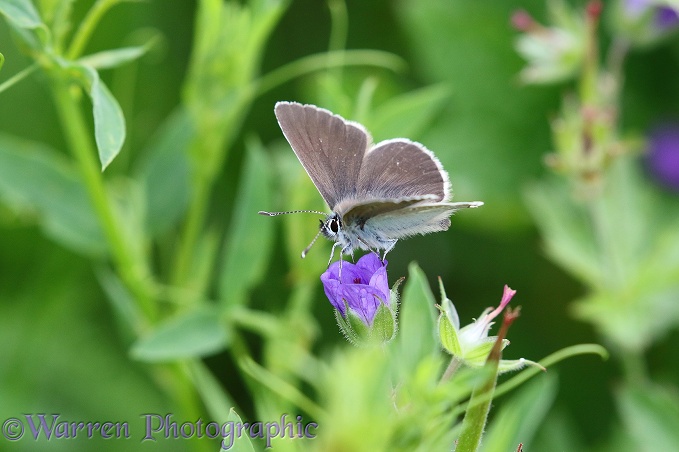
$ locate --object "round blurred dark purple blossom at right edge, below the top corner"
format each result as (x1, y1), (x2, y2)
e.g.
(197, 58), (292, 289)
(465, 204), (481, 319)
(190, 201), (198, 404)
(646, 124), (679, 191)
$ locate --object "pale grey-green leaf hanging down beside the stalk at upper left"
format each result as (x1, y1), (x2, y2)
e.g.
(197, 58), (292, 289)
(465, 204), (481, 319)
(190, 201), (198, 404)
(75, 64), (125, 171)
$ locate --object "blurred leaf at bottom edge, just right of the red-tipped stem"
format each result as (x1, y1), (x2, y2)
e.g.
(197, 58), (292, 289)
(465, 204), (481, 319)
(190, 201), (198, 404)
(481, 374), (558, 451)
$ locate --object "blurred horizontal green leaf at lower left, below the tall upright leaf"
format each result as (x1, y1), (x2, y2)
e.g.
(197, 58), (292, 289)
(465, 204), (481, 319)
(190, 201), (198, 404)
(131, 306), (228, 362)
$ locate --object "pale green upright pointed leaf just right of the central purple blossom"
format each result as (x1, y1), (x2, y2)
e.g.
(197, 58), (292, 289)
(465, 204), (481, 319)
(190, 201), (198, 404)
(394, 263), (440, 372)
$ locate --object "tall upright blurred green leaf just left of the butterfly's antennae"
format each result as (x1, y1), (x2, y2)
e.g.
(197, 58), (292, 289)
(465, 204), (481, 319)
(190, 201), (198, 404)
(220, 140), (274, 306)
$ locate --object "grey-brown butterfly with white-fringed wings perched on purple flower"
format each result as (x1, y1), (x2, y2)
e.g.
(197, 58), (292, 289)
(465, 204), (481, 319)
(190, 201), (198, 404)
(259, 102), (483, 261)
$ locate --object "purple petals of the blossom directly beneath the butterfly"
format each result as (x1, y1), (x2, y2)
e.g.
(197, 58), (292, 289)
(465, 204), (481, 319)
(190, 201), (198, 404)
(321, 253), (391, 326)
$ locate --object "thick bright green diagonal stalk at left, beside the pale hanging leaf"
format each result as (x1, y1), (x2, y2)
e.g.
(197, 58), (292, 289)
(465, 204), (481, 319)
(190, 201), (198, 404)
(52, 74), (155, 320)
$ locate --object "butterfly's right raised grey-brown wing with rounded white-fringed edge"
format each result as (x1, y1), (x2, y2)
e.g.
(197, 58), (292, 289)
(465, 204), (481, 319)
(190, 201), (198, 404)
(357, 138), (450, 202)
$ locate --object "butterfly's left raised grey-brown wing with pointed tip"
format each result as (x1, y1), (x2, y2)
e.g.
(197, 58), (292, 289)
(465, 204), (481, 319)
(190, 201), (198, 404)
(274, 102), (372, 210)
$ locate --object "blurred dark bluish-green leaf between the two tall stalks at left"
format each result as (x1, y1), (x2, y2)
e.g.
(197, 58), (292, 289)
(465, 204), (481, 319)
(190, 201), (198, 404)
(136, 108), (195, 236)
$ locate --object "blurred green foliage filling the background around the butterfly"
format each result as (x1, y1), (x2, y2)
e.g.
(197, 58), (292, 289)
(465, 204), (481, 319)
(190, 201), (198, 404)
(0, 0), (679, 451)
